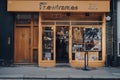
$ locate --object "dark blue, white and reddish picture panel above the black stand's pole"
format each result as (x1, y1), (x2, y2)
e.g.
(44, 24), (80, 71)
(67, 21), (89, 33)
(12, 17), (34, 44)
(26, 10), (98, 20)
(84, 28), (101, 51)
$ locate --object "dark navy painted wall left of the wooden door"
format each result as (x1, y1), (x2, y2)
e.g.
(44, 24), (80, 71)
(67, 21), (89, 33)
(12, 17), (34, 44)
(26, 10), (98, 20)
(0, 0), (14, 65)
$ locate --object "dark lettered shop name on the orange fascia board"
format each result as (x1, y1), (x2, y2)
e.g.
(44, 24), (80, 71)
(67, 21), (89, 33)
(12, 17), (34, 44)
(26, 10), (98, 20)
(40, 2), (78, 10)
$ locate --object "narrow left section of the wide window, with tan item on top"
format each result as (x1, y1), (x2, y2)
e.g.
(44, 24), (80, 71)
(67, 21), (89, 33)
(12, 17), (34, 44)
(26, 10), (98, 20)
(72, 27), (84, 60)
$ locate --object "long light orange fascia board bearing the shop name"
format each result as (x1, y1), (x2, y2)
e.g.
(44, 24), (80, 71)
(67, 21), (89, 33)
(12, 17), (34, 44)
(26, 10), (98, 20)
(7, 0), (110, 12)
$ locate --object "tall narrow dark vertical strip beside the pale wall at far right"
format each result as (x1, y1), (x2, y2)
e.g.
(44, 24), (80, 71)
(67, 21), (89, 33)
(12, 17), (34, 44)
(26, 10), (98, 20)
(111, 0), (118, 66)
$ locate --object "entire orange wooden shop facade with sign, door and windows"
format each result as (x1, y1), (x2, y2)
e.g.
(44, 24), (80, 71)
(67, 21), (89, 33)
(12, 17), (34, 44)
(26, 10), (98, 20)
(7, 0), (110, 67)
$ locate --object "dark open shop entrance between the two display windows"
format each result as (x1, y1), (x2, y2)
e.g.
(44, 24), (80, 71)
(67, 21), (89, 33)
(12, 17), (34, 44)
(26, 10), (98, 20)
(56, 26), (69, 63)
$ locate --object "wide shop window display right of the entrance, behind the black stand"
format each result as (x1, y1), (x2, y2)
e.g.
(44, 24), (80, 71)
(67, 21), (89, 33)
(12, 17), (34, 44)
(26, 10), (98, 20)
(72, 27), (102, 61)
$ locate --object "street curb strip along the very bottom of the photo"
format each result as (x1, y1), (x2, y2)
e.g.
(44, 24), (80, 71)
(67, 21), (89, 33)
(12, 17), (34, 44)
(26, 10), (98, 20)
(0, 75), (120, 80)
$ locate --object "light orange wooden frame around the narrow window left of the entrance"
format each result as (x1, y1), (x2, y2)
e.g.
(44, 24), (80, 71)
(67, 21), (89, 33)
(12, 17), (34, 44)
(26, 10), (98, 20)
(38, 25), (56, 67)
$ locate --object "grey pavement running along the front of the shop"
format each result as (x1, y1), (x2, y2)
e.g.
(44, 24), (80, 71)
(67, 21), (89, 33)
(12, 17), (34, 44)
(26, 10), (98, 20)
(0, 65), (120, 80)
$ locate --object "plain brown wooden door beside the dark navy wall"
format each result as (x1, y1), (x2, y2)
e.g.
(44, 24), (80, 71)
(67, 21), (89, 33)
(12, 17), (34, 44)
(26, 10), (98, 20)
(14, 27), (30, 63)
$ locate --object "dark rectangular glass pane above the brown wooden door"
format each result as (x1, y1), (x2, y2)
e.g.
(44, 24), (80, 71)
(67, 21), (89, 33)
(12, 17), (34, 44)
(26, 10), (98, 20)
(16, 13), (31, 24)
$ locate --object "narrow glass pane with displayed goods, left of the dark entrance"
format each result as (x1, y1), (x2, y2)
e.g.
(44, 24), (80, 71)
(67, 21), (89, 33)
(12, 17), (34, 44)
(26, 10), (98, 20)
(42, 27), (54, 60)
